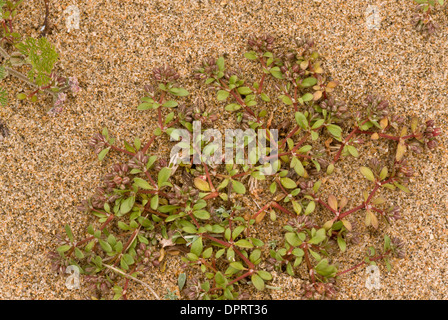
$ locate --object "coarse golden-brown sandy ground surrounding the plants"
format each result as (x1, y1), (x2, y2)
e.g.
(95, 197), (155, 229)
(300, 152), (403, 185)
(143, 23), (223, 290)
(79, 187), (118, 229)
(0, 0), (448, 299)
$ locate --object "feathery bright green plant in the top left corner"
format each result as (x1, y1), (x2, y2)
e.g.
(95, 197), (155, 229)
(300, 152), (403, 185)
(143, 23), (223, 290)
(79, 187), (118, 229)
(0, 0), (80, 113)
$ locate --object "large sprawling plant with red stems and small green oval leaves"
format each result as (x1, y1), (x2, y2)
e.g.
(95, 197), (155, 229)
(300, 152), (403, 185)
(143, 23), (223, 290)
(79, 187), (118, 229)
(51, 35), (441, 299)
